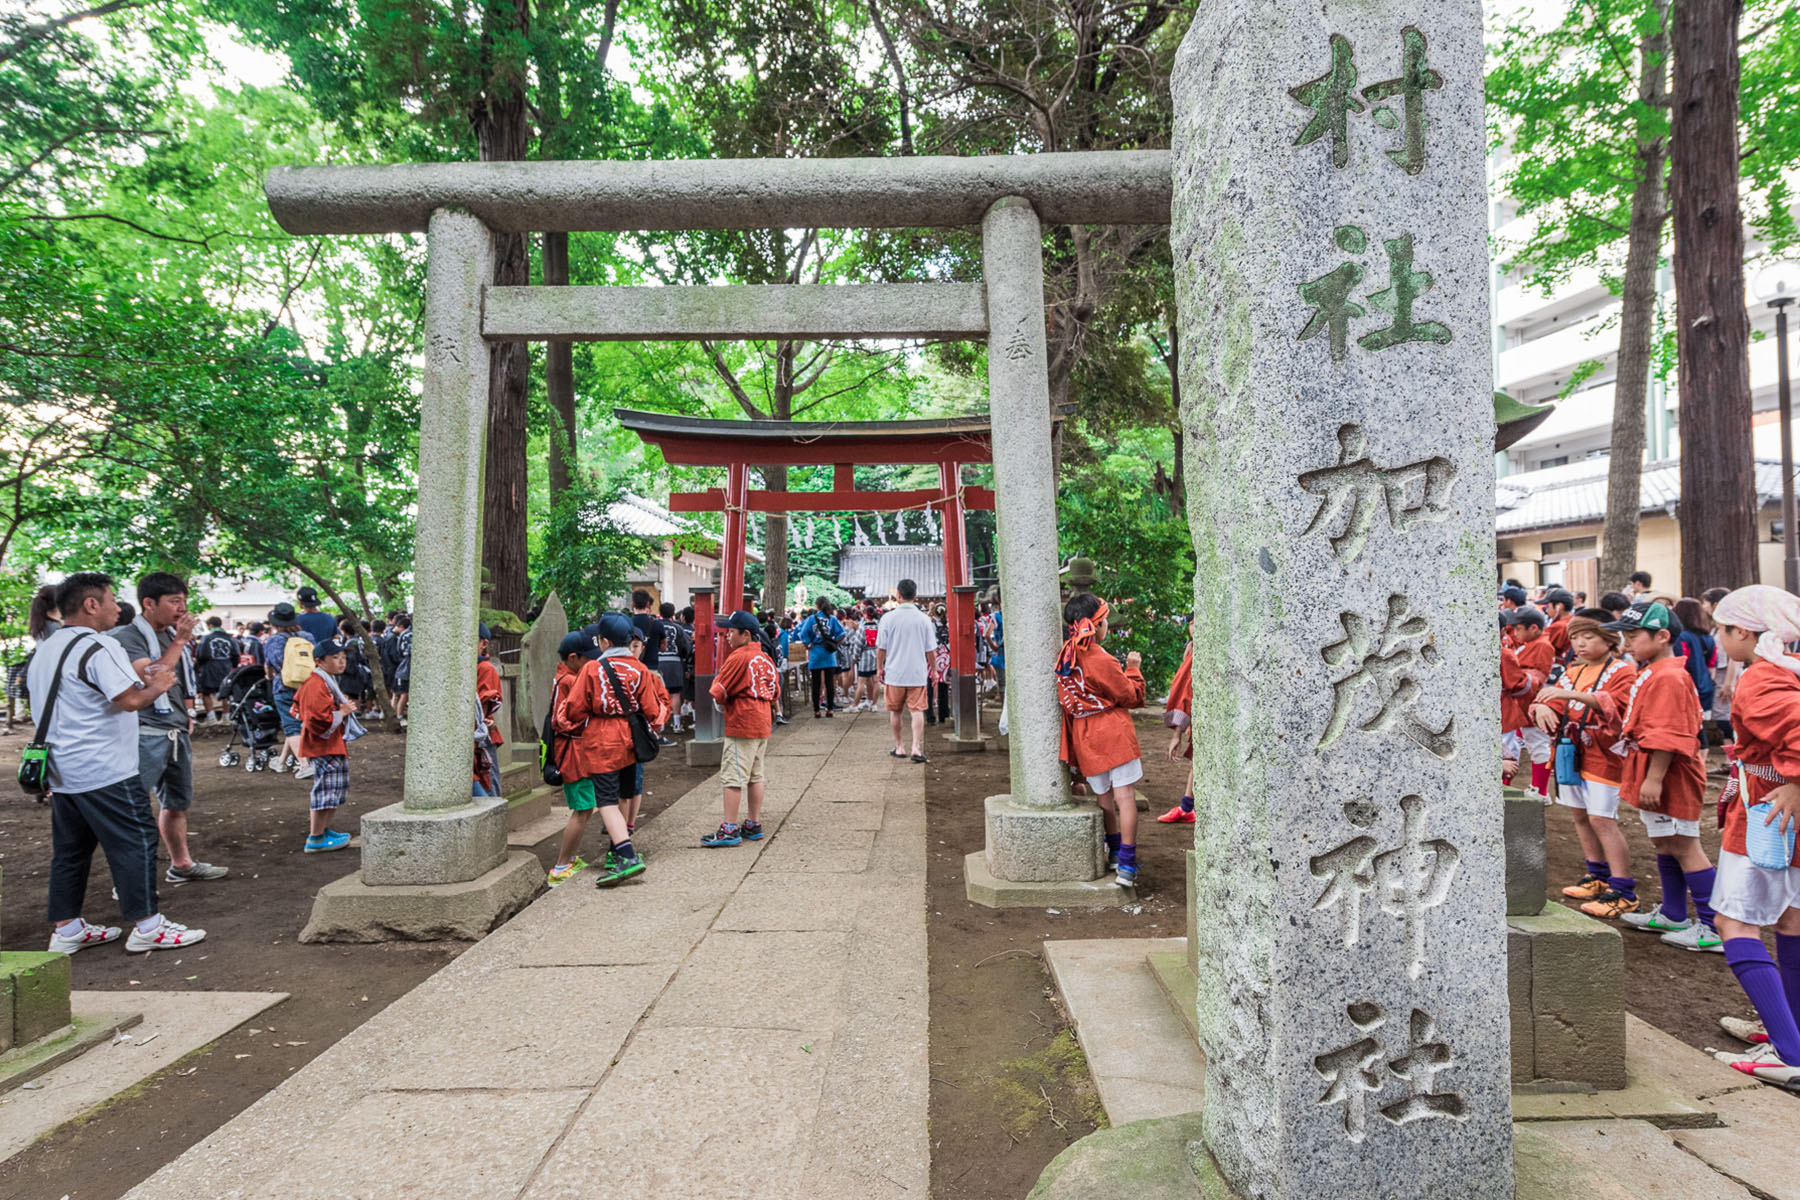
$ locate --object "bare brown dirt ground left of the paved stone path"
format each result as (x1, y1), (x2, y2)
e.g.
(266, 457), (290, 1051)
(0, 723), (711, 1200)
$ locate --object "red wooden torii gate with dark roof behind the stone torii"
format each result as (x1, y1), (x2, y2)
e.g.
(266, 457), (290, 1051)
(614, 408), (1015, 734)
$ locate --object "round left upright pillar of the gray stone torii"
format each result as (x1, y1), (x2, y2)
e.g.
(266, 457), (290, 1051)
(403, 209), (493, 811)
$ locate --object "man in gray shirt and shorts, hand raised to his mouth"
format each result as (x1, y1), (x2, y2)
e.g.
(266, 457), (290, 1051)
(112, 570), (227, 887)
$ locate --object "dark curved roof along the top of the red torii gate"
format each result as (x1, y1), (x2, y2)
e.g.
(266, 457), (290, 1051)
(612, 408), (1066, 466)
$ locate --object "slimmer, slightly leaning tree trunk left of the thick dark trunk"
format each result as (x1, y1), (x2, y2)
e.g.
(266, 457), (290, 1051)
(1595, 0), (1669, 599)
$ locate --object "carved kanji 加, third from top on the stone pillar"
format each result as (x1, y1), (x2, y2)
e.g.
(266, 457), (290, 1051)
(1300, 423), (1456, 563)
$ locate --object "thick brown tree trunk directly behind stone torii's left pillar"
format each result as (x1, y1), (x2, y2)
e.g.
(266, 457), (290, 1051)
(475, 0), (531, 613)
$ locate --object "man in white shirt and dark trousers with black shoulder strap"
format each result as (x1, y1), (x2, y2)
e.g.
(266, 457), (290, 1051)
(25, 572), (207, 954)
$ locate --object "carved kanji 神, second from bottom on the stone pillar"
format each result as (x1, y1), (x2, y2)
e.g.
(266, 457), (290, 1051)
(1309, 795), (1462, 979)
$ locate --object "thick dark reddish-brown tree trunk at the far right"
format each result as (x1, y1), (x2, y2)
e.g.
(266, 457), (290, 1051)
(1670, 0), (1757, 596)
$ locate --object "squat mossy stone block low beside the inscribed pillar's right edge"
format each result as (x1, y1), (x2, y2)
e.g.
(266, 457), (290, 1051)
(1507, 905), (1625, 1090)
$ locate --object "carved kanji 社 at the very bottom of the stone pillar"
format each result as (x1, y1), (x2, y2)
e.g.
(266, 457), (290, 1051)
(1312, 1000), (1467, 1142)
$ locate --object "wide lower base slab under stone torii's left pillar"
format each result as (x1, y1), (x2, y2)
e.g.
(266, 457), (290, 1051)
(301, 849), (544, 943)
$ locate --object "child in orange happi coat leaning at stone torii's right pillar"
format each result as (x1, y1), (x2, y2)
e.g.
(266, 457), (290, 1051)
(1057, 592), (1145, 887)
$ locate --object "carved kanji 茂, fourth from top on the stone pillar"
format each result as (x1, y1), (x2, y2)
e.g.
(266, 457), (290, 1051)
(1318, 594), (1456, 759)
